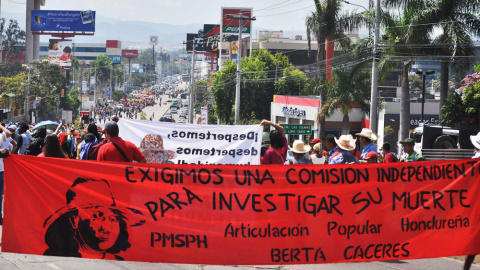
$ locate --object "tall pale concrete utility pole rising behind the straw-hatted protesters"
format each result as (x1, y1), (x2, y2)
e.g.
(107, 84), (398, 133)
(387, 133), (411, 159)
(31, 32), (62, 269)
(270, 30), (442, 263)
(370, 0), (380, 133)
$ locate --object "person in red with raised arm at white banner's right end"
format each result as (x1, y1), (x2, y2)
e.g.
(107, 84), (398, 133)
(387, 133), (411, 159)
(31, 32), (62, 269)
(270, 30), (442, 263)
(260, 120), (287, 164)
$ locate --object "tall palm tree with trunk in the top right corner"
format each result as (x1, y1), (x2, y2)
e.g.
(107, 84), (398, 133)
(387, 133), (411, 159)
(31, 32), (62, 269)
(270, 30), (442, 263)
(386, 0), (480, 117)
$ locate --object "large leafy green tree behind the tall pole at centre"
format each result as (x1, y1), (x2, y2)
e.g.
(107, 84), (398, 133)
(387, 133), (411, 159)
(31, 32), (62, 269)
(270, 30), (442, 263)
(211, 50), (306, 124)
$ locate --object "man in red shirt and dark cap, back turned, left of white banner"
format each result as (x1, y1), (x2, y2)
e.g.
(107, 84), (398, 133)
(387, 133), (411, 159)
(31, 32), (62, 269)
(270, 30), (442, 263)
(97, 121), (146, 163)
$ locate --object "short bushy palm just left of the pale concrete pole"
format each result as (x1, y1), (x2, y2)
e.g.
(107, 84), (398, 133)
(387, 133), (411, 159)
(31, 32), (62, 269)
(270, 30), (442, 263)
(319, 62), (371, 135)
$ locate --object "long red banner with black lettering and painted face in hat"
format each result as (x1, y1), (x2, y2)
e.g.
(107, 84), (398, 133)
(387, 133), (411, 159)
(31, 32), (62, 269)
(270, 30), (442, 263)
(2, 155), (480, 265)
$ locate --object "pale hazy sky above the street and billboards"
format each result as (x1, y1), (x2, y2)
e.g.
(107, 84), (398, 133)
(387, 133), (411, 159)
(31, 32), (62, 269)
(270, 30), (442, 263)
(0, 0), (369, 32)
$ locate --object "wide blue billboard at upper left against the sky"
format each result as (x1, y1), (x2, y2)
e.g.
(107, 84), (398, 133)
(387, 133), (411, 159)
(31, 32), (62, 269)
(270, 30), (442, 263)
(31, 10), (95, 32)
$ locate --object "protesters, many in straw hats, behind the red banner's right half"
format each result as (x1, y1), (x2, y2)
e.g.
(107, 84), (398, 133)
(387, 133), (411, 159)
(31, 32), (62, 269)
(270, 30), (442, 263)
(261, 120), (436, 165)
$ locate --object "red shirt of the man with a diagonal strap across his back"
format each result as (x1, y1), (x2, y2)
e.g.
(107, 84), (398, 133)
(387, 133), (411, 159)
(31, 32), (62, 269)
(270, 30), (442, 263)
(97, 137), (145, 162)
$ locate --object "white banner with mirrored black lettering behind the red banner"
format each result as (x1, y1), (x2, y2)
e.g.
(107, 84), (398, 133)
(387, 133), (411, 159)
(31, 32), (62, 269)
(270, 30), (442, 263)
(118, 119), (263, 165)
